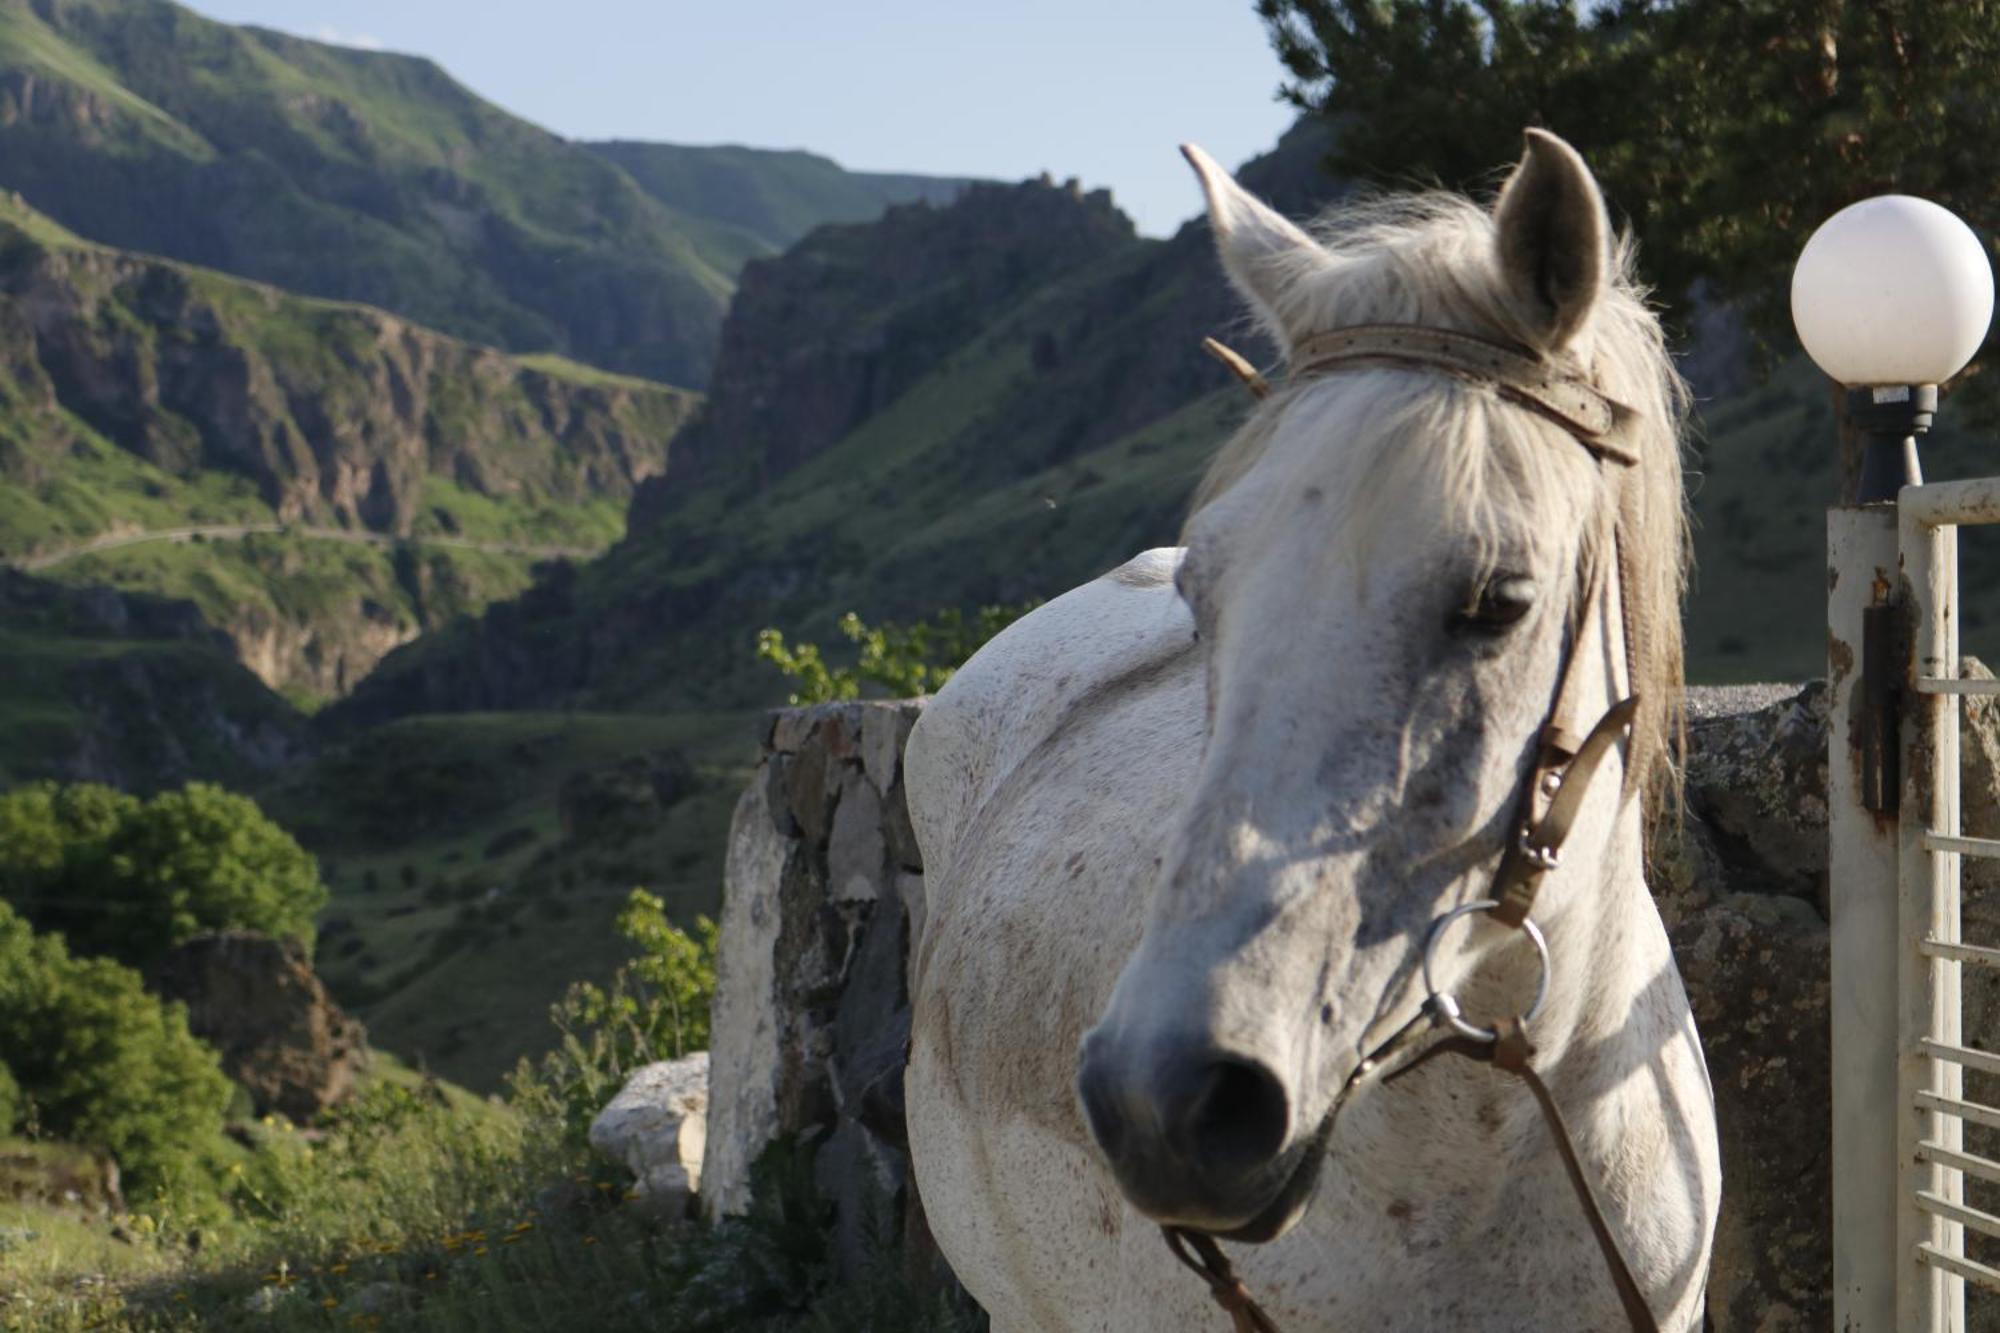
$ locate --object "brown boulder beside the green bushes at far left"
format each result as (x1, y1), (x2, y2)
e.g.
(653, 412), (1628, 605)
(148, 931), (368, 1125)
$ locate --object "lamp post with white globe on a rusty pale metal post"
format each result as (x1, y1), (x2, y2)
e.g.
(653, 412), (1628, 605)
(1816, 194), (1994, 1333)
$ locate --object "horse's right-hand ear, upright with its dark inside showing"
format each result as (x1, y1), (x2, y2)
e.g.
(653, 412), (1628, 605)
(1494, 130), (1610, 350)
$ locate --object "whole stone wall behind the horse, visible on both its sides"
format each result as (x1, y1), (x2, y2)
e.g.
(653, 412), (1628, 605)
(702, 680), (2000, 1333)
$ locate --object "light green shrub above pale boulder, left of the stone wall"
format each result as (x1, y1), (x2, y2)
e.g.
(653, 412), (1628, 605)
(510, 889), (720, 1139)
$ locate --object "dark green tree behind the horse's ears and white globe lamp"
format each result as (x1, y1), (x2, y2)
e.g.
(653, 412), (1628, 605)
(1256, 0), (2000, 342)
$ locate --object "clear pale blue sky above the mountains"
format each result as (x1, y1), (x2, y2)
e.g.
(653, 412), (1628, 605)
(172, 0), (1292, 236)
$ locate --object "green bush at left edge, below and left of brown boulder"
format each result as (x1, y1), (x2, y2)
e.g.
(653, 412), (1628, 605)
(0, 903), (230, 1193)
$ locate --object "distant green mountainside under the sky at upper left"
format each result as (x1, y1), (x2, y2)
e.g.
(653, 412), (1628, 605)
(0, 0), (960, 384)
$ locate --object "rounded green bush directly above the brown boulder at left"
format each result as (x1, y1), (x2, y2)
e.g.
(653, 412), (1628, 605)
(0, 783), (326, 969)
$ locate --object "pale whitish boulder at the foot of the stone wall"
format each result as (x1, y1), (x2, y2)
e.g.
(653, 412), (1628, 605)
(590, 1051), (708, 1217)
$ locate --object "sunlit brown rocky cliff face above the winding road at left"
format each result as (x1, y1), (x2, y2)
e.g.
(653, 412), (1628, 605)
(0, 200), (696, 554)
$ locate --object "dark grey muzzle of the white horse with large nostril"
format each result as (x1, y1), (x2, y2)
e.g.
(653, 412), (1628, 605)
(1076, 1027), (1324, 1241)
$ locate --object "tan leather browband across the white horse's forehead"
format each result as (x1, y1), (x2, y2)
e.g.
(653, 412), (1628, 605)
(1292, 324), (1638, 466)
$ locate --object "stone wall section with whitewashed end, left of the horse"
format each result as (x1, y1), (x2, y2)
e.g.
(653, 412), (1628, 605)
(702, 703), (924, 1267)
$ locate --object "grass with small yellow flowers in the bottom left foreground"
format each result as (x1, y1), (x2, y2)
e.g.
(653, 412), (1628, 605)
(0, 1040), (980, 1333)
